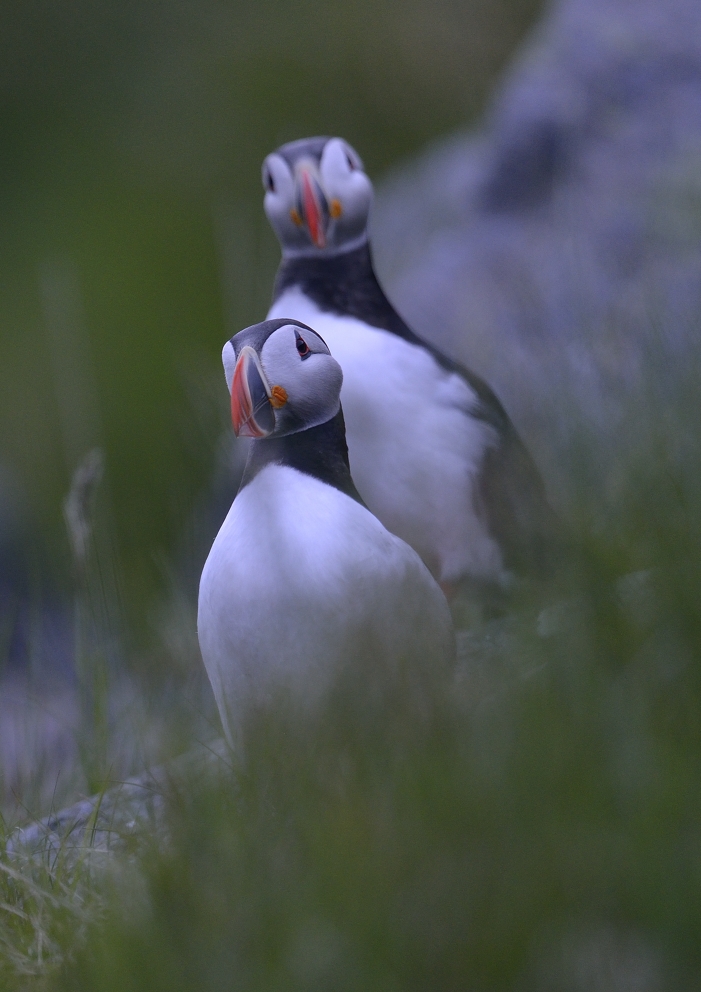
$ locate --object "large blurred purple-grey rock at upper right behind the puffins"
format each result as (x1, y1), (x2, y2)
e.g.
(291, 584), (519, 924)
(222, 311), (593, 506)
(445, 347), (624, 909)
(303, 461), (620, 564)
(373, 0), (701, 507)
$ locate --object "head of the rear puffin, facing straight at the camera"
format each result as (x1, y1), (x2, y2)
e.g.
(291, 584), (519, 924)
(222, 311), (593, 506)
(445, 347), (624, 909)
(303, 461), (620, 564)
(263, 138), (372, 257)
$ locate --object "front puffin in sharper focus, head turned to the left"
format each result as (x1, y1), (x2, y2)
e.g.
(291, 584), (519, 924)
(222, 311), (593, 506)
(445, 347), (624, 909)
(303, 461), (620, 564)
(197, 318), (455, 749)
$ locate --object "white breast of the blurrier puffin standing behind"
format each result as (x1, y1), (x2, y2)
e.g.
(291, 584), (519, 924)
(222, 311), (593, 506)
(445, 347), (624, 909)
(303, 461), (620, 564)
(268, 289), (504, 582)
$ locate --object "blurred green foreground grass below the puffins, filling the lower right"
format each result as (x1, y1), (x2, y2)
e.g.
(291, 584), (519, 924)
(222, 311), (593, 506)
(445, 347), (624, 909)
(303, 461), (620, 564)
(54, 542), (701, 990)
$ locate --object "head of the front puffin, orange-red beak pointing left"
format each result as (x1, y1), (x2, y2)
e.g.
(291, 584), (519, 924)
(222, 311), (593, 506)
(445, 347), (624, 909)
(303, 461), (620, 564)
(222, 318), (343, 438)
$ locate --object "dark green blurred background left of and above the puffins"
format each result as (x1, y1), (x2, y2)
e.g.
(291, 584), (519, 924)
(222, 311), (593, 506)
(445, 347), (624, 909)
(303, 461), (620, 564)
(0, 0), (540, 640)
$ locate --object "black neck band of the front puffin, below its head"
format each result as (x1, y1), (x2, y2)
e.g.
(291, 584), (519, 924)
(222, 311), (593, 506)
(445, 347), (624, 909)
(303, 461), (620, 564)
(239, 407), (365, 506)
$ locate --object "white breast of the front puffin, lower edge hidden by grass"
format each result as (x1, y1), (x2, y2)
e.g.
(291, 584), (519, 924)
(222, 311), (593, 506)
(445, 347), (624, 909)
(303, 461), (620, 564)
(198, 465), (454, 742)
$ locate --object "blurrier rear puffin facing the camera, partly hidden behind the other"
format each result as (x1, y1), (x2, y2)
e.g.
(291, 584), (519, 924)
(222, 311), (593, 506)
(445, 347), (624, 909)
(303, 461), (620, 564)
(263, 138), (556, 589)
